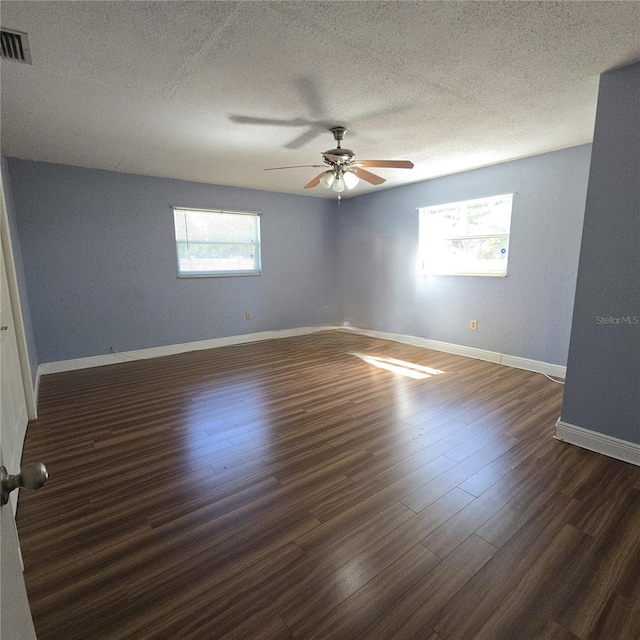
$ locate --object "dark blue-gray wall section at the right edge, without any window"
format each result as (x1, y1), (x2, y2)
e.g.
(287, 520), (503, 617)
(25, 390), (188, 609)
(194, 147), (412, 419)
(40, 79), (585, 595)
(562, 63), (640, 444)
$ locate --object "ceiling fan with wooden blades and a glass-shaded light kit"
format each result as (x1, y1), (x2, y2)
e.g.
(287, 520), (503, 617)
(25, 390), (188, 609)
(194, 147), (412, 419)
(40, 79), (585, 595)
(265, 127), (413, 197)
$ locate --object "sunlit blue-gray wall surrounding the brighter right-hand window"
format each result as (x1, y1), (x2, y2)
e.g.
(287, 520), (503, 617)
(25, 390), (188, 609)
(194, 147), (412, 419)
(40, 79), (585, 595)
(340, 145), (591, 365)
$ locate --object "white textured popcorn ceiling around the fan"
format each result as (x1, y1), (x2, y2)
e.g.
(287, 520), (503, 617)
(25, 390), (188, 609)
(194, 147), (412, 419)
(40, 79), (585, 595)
(0, 0), (640, 197)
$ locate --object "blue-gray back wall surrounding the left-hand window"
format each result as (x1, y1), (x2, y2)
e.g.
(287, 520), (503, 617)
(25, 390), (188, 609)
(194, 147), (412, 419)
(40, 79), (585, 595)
(8, 158), (338, 363)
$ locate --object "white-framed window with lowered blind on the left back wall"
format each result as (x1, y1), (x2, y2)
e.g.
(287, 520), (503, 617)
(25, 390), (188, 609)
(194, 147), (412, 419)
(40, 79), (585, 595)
(173, 207), (262, 276)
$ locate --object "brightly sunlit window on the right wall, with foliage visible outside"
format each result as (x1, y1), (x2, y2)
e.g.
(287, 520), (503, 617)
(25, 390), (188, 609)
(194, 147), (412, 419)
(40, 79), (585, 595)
(418, 193), (513, 276)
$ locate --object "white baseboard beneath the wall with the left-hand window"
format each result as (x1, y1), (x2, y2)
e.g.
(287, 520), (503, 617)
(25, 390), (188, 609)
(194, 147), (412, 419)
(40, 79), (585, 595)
(36, 326), (336, 384)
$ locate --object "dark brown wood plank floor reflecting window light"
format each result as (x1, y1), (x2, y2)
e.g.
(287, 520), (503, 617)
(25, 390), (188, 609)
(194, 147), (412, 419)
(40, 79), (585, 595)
(18, 332), (640, 640)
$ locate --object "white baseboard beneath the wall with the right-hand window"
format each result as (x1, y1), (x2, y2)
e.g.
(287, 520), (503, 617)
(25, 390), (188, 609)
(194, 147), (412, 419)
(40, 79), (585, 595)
(343, 326), (567, 378)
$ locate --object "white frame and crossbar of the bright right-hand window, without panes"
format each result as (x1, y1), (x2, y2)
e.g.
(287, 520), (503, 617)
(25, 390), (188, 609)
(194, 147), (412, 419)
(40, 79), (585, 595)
(417, 191), (516, 278)
